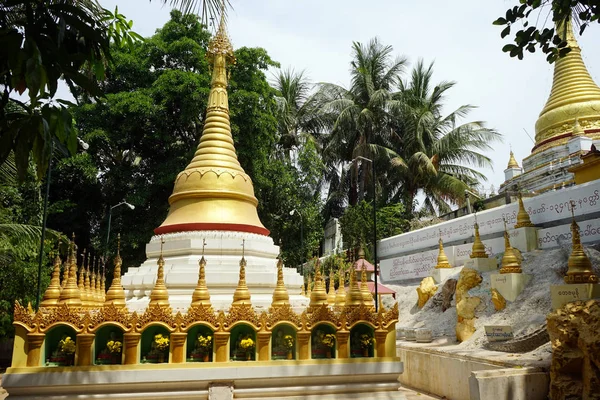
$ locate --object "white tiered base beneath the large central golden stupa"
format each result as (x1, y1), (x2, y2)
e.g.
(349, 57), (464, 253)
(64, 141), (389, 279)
(121, 231), (309, 311)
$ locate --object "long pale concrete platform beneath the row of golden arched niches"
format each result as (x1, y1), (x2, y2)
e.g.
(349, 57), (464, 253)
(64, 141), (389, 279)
(2, 357), (403, 400)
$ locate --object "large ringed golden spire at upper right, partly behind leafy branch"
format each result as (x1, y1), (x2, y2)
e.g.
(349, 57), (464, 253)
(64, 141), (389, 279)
(533, 17), (600, 152)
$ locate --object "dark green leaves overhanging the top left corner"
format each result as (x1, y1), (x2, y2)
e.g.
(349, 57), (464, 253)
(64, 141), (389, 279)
(0, 0), (139, 180)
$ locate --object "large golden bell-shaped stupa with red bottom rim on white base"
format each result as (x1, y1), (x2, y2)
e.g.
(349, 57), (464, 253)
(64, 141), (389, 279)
(154, 10), (269, 235)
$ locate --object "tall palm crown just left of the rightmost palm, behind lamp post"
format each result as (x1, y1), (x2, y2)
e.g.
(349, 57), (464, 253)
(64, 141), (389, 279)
(315, 38), (406, 204)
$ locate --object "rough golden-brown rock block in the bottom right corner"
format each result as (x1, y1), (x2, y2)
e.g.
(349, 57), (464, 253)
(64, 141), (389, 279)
(547, 300), (600, 400)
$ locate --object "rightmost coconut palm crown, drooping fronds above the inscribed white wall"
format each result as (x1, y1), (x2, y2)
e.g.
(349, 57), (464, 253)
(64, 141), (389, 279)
(387, 61), (501, 215)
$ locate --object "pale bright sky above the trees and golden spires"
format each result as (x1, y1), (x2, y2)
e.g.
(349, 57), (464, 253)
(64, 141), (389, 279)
(100, 0), (600, 191)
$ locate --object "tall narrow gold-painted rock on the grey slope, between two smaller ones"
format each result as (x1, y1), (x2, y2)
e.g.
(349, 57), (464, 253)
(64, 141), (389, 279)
(456, 268), (482, 342)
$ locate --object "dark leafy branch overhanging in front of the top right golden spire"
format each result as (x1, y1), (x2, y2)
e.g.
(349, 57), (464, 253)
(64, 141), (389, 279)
(494, 0), (600, 63)
